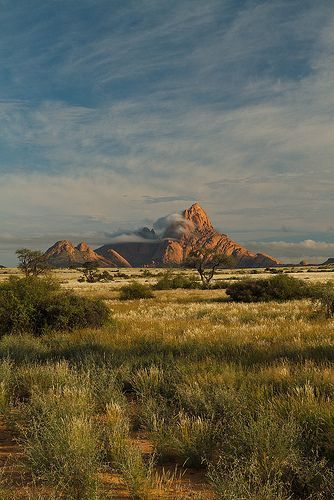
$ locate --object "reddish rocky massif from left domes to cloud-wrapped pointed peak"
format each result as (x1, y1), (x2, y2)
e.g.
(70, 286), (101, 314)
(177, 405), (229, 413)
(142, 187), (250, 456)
(46, 203), (281, 267)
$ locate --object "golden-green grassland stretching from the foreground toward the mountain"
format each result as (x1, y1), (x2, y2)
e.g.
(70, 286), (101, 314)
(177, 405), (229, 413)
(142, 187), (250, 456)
(0, 270), (334, 500)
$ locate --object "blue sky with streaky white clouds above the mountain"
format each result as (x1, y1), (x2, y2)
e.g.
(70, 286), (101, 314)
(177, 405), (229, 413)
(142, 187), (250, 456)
(0, 0), (334, 265)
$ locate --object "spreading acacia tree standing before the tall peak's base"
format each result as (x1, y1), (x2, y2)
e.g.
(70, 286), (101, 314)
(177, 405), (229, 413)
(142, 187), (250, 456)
(185, 247), (235, 288)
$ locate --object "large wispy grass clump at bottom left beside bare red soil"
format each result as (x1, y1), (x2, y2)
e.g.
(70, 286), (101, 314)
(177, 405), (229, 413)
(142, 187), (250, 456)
(19, 388), (102, 500)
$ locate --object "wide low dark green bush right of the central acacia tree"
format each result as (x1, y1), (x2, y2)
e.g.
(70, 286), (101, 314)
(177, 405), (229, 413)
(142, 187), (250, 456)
(226, 274), (312, 302)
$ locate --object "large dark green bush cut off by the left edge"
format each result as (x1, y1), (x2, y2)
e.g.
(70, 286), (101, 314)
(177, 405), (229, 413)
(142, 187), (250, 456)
(0, 277), (109, 335)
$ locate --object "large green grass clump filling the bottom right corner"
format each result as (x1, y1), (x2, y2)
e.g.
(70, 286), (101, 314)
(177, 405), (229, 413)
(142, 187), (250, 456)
(208, 406), (333, 500)
